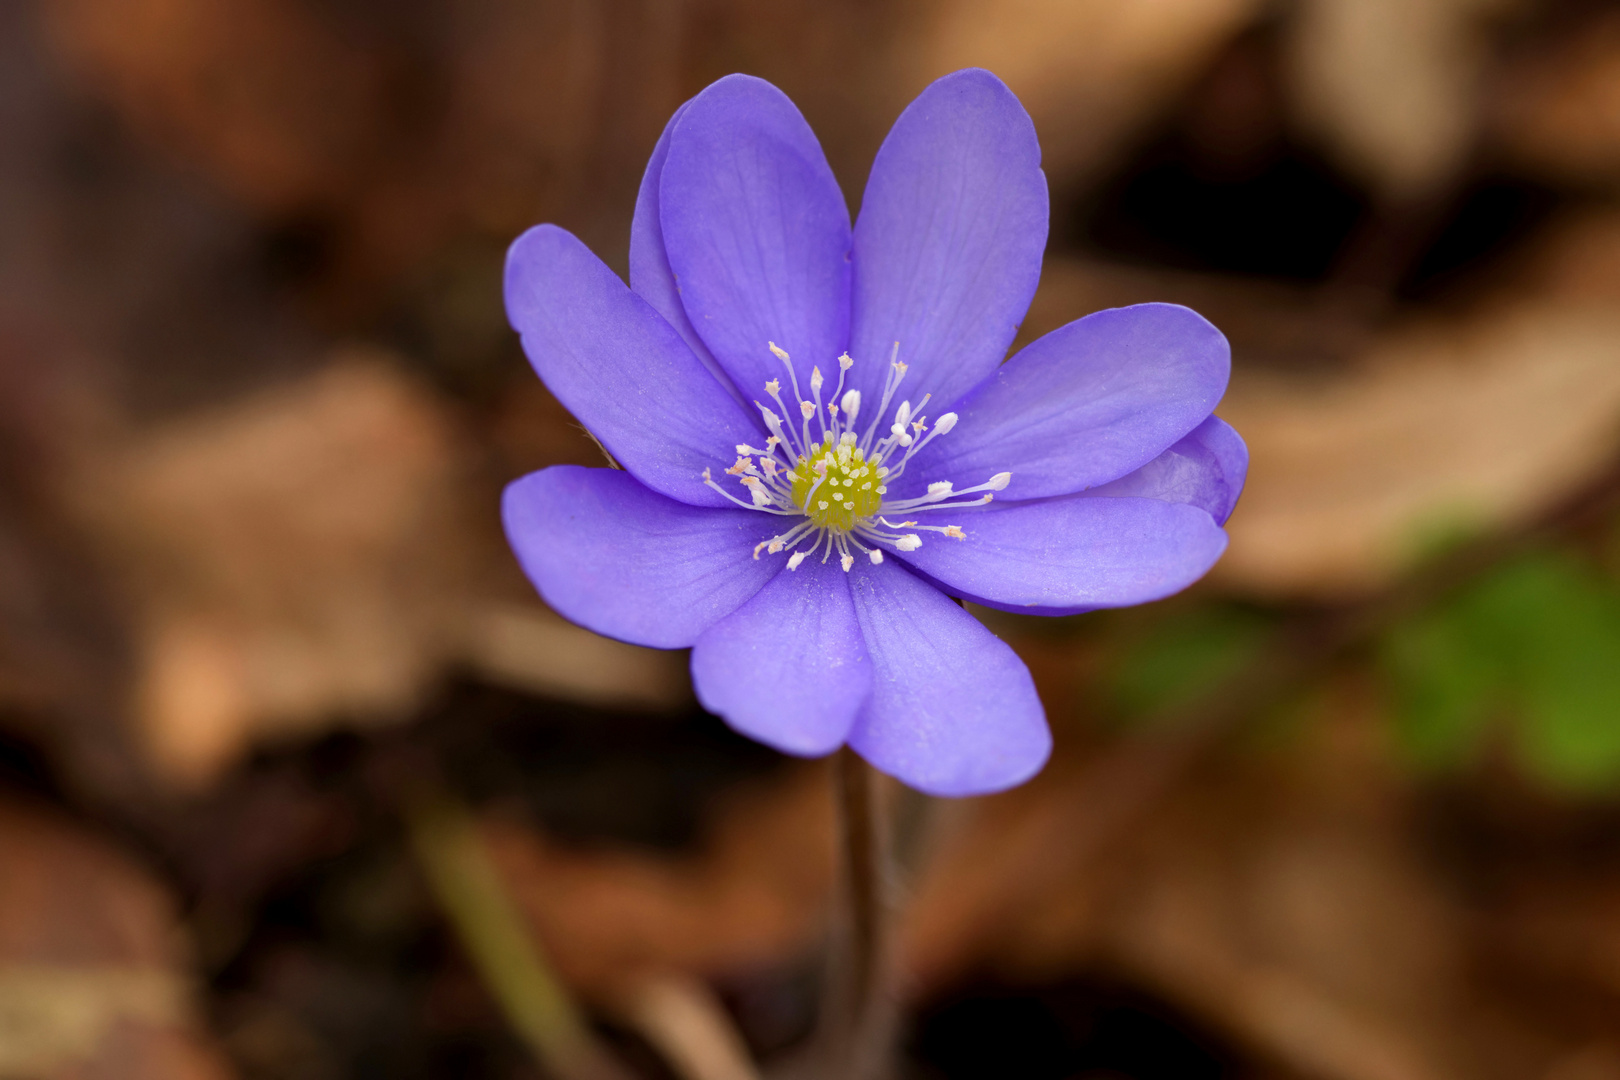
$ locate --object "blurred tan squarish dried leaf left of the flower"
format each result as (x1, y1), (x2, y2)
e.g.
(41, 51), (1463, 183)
(75, 355), (467, 784)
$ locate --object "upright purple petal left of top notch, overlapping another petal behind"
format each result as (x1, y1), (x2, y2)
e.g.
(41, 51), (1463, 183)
(658, 74), (849, 400)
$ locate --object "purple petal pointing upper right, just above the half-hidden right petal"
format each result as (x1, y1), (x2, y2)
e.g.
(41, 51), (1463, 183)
(904, 304), (1231, 499)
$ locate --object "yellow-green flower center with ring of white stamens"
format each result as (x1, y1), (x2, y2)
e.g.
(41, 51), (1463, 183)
(703, 342), (1013, 573)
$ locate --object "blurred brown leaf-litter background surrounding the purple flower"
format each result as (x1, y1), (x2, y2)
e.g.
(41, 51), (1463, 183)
(0, 0), (1620, 1080)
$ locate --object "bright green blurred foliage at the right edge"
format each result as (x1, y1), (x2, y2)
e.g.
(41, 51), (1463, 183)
(1380, 551), (1620, 790)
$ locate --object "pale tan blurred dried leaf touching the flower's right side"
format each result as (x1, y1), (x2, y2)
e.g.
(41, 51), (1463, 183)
(1215, 301), (1620, 597)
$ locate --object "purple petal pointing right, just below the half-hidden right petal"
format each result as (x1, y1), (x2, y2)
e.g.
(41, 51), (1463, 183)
(902, 495), (1226, 614)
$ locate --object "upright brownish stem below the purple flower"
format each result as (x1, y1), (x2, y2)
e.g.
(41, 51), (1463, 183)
(821, 746), (896, 1080)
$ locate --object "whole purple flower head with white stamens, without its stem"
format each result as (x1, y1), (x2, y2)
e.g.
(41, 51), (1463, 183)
(504, 70), (1247, 795)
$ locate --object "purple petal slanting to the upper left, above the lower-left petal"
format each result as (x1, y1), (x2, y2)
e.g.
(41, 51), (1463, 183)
(505, 225), (763, 507)
